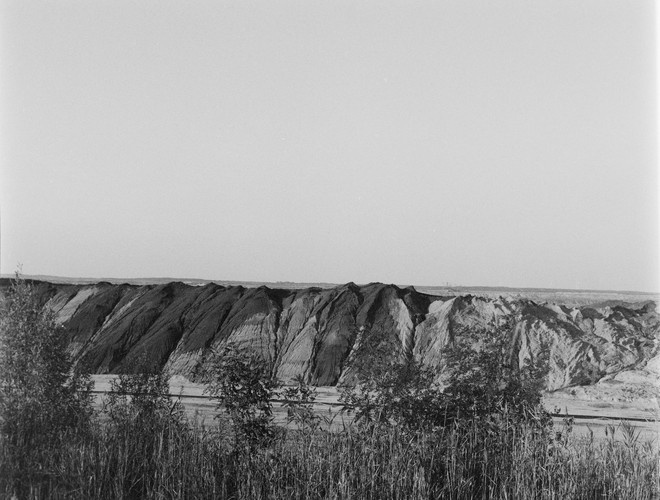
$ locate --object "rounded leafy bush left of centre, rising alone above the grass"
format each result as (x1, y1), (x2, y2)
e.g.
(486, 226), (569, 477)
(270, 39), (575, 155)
(206, 344), (280, 448)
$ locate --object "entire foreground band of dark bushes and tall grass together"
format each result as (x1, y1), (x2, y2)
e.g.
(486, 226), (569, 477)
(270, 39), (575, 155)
(0, 280), (660, 499)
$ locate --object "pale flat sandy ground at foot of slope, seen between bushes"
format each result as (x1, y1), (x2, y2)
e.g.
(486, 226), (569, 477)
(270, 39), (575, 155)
(92, 375), (660, 447)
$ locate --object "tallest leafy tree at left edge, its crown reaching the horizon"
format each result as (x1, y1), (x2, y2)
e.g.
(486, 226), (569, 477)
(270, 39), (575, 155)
(0, 273), (92, 446)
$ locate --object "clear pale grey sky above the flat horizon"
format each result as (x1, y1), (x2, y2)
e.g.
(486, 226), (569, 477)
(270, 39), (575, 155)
(0, 0), (660, 292)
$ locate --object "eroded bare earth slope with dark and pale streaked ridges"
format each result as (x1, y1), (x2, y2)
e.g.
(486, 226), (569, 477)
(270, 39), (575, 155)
(0, 280), (660, 399)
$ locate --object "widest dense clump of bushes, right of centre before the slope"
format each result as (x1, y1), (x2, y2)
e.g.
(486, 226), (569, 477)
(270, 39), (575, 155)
(340, 323), (551, 431)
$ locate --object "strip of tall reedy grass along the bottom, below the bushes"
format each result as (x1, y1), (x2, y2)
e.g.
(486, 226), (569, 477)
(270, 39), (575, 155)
(0, 406), (660, 500)
